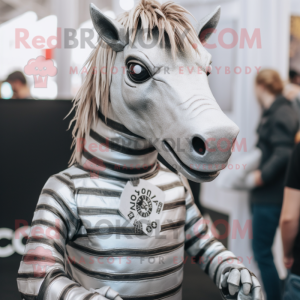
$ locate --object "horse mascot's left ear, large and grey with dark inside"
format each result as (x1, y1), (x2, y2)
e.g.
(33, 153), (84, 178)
(90, 3), (128, 52)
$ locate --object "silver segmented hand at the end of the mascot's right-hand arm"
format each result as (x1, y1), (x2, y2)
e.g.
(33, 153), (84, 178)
(219, 268), (264, 300)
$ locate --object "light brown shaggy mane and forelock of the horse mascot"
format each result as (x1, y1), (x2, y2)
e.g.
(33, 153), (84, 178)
(70, 0), (200, 165)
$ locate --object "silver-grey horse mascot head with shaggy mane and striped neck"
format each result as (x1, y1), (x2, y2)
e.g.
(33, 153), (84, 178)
(72, 0), (239, 182)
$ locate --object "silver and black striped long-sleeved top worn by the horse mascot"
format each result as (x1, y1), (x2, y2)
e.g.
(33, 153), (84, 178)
(17, 113), (238, 300)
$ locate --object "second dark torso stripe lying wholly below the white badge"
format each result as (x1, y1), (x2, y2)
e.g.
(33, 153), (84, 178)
(72, 261), (183, 281)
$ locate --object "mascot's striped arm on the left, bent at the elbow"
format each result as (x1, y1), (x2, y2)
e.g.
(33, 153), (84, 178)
(17, 174), (121, 300)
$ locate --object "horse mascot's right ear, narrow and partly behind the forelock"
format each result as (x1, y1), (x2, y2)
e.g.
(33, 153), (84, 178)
(195, 6), (221, 44)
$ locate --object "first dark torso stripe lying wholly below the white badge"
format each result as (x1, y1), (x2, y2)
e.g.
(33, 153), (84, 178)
(68, 241), (184, 257)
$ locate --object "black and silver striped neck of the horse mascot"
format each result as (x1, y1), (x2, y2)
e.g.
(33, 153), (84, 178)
(80, 112), (157, 179)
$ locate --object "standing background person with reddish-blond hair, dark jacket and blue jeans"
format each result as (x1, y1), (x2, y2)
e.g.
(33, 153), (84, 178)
(249, 69), (298, 300)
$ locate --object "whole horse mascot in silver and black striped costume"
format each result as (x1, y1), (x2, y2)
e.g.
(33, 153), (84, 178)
(17, 0), (263, 300)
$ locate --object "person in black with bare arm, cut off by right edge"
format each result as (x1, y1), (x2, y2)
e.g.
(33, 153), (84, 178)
(280, 144), (300, 300)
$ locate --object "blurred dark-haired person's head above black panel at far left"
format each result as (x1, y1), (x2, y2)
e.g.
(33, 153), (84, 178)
(5, 71), (31, 99)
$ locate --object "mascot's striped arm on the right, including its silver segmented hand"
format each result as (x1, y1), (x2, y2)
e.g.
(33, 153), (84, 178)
(181, 176), (263, 300)
